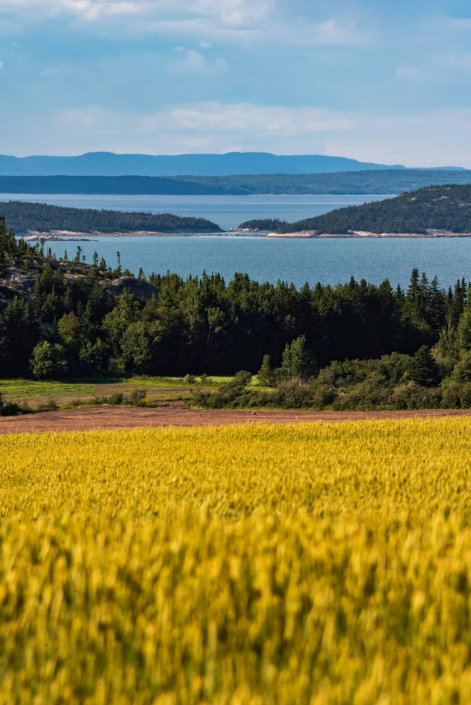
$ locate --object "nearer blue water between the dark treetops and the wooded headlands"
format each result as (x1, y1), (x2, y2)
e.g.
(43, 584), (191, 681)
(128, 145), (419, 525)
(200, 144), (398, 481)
(51, 236), (471, 286)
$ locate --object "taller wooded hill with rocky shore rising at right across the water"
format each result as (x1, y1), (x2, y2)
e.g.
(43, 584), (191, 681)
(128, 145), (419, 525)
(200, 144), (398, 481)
(277, 185), (471, 234)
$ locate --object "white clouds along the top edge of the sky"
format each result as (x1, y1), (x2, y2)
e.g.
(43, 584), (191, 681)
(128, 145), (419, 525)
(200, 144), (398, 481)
(0, 0), (371, 49)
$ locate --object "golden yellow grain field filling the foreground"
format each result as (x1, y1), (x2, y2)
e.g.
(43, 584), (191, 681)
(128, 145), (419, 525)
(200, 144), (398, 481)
(0, 419), (471, 705)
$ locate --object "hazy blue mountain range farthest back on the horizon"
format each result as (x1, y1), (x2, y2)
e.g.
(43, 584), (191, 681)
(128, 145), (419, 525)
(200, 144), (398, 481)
(0, 152), (405, 176)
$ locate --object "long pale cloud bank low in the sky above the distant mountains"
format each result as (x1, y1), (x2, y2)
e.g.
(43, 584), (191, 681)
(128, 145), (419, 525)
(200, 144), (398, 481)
(41, 103), (471, 168)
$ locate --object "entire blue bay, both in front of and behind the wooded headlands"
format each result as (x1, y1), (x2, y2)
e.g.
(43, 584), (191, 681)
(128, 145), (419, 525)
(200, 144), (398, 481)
(6, 194), (471, 286)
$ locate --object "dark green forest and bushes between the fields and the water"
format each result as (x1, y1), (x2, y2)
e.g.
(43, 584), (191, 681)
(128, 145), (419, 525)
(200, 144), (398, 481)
(0, 216), (471, 408)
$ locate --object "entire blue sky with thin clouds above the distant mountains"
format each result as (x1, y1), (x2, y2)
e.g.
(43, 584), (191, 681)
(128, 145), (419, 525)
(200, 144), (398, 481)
(0, 0), (471, 168)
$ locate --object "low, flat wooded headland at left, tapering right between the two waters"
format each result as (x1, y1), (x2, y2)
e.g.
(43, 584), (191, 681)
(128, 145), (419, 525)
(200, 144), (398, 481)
(0, 201), (221, 234)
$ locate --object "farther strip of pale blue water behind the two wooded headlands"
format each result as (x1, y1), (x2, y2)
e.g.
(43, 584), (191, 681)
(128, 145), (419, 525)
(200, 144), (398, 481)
(0, 193), (388, 229)
